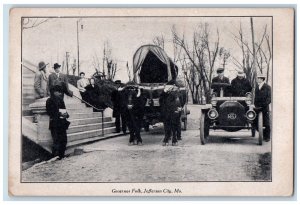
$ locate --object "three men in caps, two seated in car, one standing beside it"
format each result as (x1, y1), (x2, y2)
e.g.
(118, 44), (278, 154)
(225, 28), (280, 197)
(212, 68), (271, 142)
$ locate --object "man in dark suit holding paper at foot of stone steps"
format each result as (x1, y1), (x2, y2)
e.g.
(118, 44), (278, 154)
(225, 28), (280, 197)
(46, 85), (70, 159)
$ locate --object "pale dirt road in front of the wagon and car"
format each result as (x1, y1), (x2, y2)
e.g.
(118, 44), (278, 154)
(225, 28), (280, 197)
(22, 106), (271, 182)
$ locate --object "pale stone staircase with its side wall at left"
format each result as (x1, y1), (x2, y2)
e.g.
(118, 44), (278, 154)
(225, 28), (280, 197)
(22, 64), (118, 152)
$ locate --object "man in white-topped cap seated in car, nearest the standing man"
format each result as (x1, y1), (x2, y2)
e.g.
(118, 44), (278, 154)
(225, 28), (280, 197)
(231, 71), (252, 97)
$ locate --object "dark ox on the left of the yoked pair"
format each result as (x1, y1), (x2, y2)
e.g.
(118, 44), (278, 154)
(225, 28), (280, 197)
(121, 85), (146, 145)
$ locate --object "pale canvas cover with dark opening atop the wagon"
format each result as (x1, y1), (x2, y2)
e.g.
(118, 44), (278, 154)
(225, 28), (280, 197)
(133, 45), (178, 83)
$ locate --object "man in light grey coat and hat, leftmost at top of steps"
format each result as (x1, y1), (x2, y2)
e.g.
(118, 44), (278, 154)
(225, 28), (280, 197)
(34, 61), (48, 99)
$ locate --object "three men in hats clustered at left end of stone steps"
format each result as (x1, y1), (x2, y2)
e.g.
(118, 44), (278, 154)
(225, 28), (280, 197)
(34, 62), (73, 159)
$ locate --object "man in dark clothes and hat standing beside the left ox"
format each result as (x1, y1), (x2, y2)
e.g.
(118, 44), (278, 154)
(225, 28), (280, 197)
(111, 80), (127, 134)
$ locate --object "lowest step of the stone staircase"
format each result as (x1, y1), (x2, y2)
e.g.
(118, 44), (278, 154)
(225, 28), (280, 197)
(68, 127), (116, 142)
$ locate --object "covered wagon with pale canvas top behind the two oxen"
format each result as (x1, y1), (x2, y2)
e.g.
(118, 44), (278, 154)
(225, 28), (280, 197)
(133, 45), (189, 131)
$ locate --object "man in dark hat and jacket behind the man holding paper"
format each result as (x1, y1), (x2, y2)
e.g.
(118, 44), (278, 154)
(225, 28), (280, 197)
(48, 63), (73, 97)
